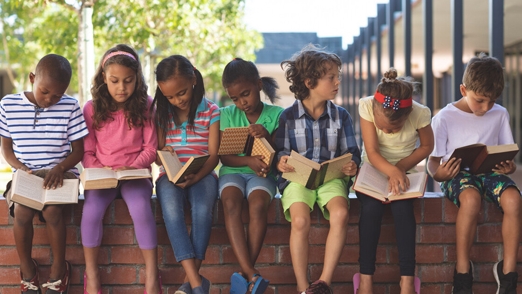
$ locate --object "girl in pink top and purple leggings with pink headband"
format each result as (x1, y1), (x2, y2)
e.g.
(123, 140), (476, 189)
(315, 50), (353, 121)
(81, 44), (162, 294)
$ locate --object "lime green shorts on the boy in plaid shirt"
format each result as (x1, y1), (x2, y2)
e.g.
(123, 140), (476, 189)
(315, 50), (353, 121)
(281, 177), (350, 222)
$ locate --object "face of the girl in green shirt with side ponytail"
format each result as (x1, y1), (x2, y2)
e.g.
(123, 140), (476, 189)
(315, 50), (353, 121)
(225, 80), (262, 114)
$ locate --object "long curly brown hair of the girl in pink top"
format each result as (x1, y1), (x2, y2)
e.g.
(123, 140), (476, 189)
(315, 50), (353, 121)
(91, 44), (149, 130)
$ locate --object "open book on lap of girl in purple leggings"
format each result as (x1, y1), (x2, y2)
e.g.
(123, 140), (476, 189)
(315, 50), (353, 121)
(80, 167), (152, 190)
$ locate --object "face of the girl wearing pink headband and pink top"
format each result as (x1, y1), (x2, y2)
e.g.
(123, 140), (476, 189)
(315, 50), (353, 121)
(103, 63), (136, 103)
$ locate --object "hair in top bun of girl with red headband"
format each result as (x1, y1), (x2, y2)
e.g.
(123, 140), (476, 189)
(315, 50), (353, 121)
(372, 67), (419, 122)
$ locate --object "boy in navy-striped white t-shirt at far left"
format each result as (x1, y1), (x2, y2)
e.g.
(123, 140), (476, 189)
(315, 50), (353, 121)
(0, 54), (88, 294)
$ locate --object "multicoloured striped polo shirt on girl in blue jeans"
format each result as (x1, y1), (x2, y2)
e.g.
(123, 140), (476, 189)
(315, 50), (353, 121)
(161, 98), (219, 173)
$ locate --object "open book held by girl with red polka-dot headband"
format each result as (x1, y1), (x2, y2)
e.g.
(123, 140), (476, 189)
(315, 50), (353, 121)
(353, 163), (428, 202)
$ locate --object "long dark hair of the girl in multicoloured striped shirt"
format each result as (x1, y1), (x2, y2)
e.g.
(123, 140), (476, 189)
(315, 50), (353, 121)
(152, 55), (205, 133)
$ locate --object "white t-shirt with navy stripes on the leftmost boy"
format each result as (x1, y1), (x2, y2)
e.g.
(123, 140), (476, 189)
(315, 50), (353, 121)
(0, 92), (88, 175)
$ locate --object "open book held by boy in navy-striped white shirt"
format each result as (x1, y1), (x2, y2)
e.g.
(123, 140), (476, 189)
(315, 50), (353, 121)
(9, 170), (80, 210)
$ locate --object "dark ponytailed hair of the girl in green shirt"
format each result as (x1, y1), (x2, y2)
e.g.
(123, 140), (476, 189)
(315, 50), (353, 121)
(221, 57), (280, 103)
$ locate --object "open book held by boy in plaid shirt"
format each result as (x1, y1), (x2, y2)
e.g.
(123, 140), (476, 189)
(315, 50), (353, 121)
(282, 150), (352, 190)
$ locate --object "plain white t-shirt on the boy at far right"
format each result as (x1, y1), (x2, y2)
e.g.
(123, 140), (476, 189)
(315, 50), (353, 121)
(430, 102), (513, 161)
